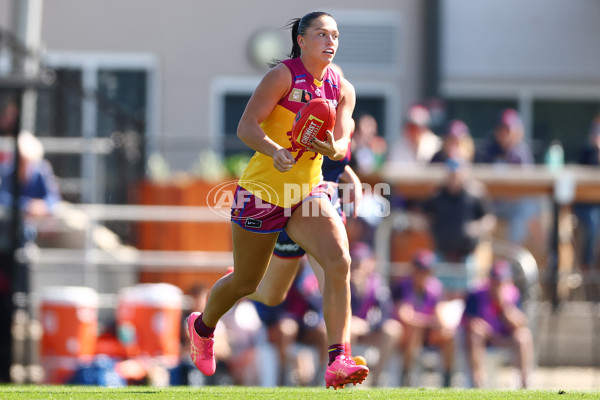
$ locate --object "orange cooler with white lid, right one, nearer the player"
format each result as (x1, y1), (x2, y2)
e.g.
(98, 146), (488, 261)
(117, 283), (183, 365)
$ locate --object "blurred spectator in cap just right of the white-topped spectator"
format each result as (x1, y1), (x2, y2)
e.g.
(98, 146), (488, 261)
(431, 119), (475, 163)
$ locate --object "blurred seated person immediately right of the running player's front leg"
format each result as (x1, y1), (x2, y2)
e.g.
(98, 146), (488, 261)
(350, 242), (402, 386)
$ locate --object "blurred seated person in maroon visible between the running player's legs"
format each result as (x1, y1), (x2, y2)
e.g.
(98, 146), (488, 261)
(252, 263), (327, 386)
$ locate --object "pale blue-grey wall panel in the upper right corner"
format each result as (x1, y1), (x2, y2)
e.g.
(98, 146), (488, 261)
(441, 0), (600, 82)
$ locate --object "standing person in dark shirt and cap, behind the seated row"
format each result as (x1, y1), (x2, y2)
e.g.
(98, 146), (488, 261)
(423, 158), (496, 298)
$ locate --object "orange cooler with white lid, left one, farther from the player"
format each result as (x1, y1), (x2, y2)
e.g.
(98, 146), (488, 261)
(40, 286), (98, 383)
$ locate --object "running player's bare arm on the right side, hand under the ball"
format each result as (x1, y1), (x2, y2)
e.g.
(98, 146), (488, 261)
(311, 78), (356, 160)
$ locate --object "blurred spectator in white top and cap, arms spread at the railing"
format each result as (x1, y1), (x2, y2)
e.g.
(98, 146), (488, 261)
(388, 104), (442, 165)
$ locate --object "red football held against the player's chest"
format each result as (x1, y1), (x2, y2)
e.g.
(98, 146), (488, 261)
(292, 97), (335, 147)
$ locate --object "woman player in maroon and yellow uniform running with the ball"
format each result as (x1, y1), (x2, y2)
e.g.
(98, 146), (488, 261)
(188, 12), (369, 389)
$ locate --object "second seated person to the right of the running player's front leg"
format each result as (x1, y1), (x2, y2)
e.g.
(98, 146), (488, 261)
(391, 250), (456, 387)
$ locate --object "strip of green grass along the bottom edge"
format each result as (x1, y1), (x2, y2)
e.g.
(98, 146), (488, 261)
(0, 385), (600, 400)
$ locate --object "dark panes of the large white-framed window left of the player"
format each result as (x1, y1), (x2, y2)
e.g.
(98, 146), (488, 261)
(36, 68), (147, 204)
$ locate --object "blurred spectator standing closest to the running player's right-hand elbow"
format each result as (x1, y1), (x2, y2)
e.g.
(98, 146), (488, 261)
(350, 114), (387, 175)
